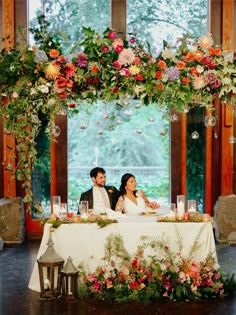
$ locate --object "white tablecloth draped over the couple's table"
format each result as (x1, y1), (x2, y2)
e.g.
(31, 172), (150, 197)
(29, 216), (217, 291)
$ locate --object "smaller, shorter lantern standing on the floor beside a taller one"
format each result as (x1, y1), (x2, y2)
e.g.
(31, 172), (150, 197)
(60, 257), (79, 299)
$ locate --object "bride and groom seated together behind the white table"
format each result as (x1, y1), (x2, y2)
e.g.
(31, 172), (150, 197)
(80, 167), (159, 213)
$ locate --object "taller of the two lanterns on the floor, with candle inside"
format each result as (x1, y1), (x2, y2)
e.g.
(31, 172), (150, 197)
(37, 234), (64, 299)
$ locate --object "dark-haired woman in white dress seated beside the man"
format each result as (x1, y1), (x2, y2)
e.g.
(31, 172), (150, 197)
(115, 173), (159, 214)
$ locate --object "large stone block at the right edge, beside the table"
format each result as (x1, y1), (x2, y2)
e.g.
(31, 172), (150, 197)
(214, 195), (236, 244)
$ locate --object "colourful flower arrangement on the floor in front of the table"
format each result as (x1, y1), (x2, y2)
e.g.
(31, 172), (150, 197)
(79, 235), (236, 303)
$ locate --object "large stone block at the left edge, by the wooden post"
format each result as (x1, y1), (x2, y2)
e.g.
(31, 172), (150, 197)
(0, 197), (25, 245)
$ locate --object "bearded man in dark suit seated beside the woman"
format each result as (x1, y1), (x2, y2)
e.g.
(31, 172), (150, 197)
(80, 167), (120, 211)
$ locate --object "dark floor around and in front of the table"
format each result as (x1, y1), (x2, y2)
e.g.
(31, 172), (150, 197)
(0, 241), (236, 315)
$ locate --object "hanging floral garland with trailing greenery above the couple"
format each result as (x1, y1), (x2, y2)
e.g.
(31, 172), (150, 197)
(0, 16), (236, 210)
